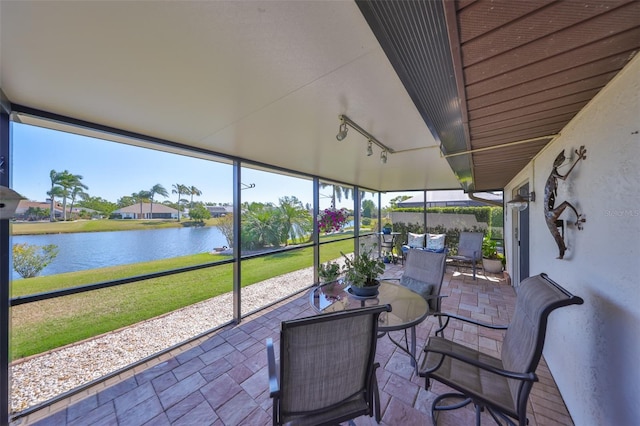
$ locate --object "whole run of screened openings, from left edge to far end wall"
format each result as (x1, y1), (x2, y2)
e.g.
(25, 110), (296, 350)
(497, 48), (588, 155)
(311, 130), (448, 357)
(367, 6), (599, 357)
(10, 118), (502, 414)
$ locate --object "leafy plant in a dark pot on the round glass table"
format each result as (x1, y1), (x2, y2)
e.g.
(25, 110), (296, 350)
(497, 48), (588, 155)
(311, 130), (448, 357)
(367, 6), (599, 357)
(341, 244), (384, 296)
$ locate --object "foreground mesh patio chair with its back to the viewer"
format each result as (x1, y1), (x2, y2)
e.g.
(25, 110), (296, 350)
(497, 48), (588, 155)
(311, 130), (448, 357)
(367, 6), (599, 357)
(267, 305), (391, 425)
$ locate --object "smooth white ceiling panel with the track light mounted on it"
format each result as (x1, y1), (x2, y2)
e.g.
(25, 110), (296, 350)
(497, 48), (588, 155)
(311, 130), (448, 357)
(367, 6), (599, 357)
(0, 0), (459, 190)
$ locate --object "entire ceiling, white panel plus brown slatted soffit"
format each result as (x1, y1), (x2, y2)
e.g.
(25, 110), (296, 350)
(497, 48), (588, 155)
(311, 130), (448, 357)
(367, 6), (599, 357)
(0, 0), (640, 191)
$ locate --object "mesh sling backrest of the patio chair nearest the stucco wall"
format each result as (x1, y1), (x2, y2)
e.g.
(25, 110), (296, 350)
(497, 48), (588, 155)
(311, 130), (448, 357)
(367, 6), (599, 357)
(501, 274), (583, 407)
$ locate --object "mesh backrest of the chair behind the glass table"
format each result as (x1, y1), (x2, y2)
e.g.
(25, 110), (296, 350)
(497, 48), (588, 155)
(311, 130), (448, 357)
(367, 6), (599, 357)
(400, 249), (447, 313)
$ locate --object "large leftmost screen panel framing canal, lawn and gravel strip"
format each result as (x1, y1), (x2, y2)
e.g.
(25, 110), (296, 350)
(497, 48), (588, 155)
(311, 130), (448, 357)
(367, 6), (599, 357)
(10, 122), (240, 412)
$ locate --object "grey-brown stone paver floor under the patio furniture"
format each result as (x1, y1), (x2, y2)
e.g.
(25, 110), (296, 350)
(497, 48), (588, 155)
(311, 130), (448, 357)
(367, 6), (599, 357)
(14, 265), (573, 426)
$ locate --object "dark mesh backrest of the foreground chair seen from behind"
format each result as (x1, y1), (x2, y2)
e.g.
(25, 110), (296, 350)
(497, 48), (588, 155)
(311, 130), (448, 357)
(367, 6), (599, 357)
(279, 305), (391, 421)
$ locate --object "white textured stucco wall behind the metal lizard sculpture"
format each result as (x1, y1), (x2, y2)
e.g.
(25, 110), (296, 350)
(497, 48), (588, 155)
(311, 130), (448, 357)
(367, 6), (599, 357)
(505, 55), (640, 426)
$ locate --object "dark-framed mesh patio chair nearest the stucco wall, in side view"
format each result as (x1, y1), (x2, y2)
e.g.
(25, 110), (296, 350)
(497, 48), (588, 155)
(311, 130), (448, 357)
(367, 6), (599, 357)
(419, 274), (583, 426)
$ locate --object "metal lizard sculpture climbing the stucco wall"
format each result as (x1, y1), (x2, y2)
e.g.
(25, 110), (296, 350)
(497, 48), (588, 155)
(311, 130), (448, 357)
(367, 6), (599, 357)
(544, 145), (587, 259)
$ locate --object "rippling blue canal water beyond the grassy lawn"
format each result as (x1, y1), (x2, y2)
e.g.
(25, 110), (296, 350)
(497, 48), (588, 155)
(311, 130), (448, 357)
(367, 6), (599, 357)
(11, 226), (227, 279)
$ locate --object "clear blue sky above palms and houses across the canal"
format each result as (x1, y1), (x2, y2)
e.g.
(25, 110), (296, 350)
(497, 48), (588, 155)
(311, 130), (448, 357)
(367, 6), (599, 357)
(11, 122), (410, 208)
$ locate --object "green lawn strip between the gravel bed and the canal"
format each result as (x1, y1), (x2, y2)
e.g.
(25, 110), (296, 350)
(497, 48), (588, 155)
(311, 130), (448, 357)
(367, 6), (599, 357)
(11, 239), (353, 359)
